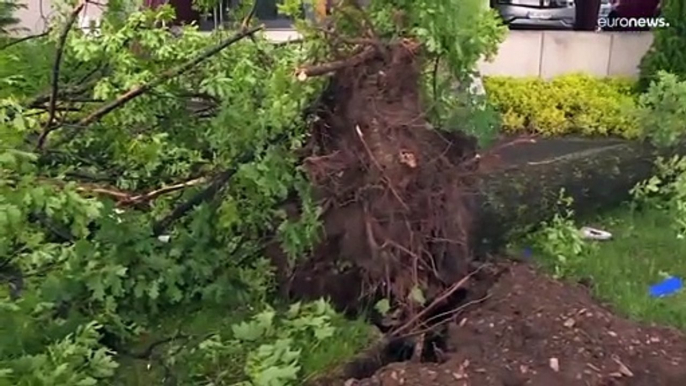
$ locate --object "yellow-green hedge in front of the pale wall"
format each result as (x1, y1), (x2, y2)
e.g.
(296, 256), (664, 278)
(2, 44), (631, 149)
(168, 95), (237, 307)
(485, 74), (639, 138)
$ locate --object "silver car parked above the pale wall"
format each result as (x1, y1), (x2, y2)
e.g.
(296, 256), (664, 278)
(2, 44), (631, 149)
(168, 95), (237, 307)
(491, 0), (612, 29)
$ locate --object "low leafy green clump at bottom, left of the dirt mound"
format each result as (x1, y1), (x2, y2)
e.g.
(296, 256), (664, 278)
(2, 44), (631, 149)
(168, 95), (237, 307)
(110, 300), (376, 386)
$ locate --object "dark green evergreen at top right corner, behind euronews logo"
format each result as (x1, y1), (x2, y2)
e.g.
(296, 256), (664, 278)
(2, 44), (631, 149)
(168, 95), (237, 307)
(639, 0), (686, 90)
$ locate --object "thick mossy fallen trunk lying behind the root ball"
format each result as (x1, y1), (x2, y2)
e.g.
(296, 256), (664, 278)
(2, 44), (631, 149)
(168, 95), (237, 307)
(475, 139), (658, 251)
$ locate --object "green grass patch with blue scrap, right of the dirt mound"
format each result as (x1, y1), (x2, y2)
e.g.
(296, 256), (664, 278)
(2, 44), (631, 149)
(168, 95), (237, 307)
(537, 208), (686, 330)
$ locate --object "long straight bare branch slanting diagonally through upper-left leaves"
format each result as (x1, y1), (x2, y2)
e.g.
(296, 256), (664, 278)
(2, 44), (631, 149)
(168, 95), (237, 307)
(51, 26), (264, 145)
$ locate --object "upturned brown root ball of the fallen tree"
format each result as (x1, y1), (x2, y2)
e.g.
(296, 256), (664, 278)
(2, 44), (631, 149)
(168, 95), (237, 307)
(274, 40), (476, 316)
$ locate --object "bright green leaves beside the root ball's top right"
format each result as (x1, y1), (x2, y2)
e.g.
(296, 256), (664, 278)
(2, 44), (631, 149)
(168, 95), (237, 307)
(390, 0), (507, 145)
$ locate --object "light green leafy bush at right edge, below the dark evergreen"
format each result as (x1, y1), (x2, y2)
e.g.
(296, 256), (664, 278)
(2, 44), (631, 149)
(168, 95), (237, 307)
(636, 72), (686, 146)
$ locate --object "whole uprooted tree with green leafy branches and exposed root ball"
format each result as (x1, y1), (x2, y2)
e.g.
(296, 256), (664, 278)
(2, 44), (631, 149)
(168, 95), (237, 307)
(0, 0), (502, 385)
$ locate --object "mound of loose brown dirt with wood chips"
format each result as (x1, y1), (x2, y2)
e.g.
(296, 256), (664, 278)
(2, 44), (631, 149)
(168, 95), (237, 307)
(354, 264), (686, 386)
